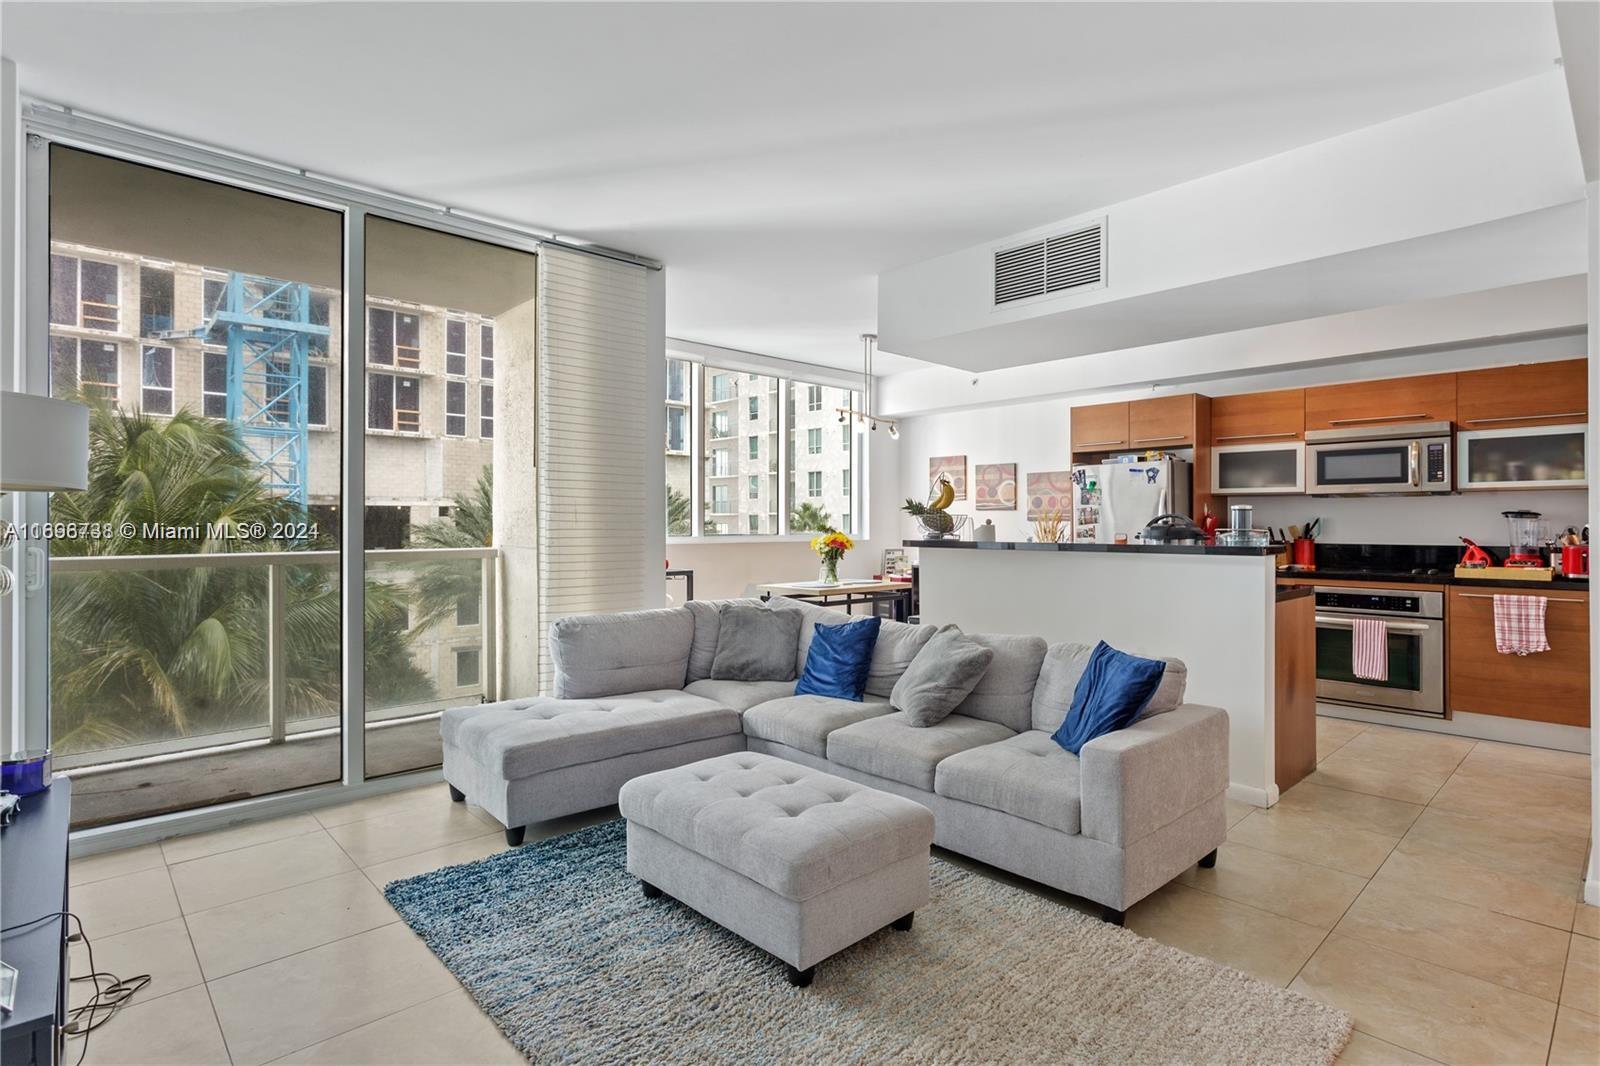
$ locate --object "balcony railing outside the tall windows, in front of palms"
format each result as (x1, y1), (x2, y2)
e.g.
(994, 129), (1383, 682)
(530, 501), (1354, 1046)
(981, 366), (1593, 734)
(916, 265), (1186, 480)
(50, 547), (501, 770)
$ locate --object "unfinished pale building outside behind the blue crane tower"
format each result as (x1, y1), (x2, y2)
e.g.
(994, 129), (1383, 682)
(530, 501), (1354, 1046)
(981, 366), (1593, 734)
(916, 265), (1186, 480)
(50, 242), (494, 547)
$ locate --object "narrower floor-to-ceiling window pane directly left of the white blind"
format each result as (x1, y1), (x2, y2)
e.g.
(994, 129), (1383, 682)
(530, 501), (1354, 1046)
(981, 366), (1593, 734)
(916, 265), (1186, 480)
(363, 218), (538, 776)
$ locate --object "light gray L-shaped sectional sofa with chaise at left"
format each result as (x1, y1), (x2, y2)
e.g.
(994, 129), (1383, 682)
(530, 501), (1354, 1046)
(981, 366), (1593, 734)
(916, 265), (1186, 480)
(440, 599), (1229, 920)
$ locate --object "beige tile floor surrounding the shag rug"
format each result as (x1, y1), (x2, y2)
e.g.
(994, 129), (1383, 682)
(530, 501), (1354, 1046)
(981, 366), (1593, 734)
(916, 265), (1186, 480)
(69, 719), (1600, 1064)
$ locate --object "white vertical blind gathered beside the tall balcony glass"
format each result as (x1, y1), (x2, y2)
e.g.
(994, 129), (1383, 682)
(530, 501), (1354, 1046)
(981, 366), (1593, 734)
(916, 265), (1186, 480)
(538, 246), (661, 693)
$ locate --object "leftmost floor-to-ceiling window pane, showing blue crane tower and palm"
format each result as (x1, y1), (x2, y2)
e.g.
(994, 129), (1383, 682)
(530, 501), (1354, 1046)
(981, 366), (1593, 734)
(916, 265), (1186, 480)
(50, 146), (344, 826)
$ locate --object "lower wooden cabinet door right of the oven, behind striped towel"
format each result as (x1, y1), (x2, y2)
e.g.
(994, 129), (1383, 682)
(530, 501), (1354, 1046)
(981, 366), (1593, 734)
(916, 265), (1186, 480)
(1445, 587), (1589, 725)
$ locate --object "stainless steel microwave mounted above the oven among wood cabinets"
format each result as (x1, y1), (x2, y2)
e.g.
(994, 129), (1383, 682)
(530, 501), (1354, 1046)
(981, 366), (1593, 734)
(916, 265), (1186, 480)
(1306, 423), (1454, 496)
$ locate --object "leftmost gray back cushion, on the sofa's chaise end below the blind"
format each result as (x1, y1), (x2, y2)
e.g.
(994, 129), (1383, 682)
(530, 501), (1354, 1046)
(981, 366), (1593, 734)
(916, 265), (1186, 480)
(550, 607), (694, 699)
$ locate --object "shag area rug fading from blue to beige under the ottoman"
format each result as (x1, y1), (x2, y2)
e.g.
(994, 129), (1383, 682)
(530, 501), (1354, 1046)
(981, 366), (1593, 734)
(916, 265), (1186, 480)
(384, 820), (1350, 1066)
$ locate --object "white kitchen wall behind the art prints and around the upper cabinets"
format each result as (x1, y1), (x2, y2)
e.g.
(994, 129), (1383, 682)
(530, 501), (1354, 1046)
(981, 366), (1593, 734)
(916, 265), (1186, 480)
(898, 336), (1587, 544)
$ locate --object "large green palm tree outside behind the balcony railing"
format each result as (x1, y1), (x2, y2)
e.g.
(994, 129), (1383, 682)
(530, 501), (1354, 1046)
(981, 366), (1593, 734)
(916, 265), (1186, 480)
(51, 399), (432, 752)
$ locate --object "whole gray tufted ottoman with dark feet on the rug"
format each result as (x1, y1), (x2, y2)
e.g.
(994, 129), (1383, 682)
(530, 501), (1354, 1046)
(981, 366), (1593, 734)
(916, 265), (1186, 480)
(618, 752), (933, 988)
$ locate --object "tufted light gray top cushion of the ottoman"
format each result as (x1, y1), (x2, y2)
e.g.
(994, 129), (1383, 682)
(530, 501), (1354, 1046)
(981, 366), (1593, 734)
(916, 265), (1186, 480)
(618, 751), (933, 900)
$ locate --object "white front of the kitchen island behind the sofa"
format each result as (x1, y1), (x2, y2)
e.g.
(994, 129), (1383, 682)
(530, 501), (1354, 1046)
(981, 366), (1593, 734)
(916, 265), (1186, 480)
(904, 541), (1278, 807)
